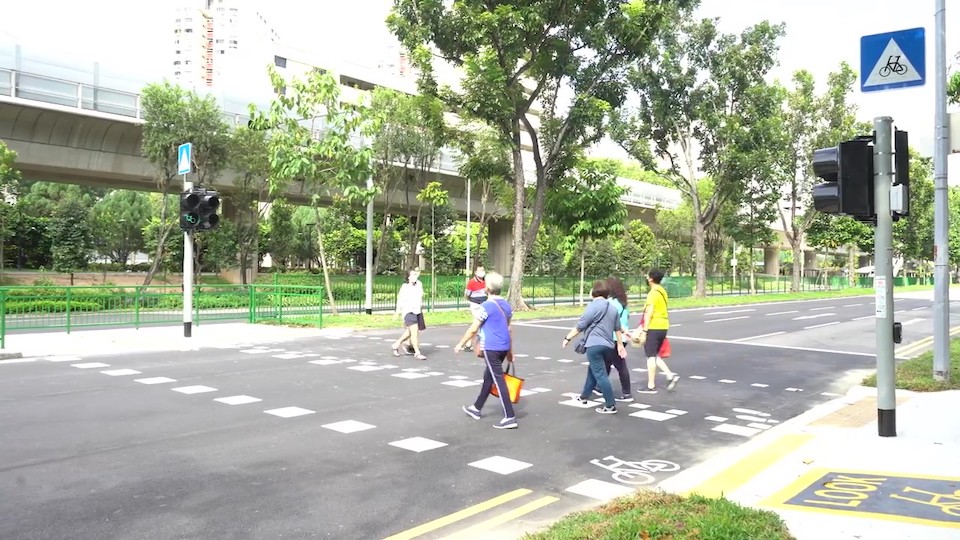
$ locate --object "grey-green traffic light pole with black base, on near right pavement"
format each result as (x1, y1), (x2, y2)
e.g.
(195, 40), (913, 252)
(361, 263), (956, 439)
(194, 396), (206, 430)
(873, 116), (897, 437)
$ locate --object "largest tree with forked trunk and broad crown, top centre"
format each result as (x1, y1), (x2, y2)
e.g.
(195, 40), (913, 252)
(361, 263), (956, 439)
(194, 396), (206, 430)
(388, 0), (695, 309)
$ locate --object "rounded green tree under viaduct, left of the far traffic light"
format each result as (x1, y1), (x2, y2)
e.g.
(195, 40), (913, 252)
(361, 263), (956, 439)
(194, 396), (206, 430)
(92, 189), (153, 266)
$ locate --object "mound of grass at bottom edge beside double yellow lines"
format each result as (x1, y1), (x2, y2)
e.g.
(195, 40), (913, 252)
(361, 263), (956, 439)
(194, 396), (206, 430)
(524, 491), (794, 540)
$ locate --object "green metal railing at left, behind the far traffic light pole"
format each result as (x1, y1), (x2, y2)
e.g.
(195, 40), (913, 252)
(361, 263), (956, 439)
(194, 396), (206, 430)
(0, 284), (324, 348)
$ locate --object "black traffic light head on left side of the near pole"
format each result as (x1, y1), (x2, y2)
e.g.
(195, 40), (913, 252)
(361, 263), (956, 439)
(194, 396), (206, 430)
(813, 137), (874, 221)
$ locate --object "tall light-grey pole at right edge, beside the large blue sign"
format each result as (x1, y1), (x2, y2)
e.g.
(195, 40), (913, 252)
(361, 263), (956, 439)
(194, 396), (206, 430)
(933, 0), (950, 381)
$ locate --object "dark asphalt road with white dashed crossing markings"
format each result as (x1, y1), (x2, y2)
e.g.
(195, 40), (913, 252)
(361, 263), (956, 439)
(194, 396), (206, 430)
(0, 299), (944, 540)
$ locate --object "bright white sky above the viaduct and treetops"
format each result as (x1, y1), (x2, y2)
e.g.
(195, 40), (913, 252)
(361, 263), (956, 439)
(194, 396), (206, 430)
(0, 0), (960, 171)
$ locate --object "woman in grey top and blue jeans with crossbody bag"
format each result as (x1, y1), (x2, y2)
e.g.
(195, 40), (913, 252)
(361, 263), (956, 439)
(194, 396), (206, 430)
(563, 281), (627, 414)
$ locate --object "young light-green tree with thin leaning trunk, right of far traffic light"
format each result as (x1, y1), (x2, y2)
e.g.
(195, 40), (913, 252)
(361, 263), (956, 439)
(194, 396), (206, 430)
(250, 66), (377, 314)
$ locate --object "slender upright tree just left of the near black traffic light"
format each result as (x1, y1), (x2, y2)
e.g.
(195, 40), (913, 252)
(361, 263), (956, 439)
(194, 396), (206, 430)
(779, 62), (857, 291)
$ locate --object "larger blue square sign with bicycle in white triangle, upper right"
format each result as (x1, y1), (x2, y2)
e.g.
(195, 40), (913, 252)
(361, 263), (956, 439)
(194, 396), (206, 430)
(860, 28), (927, 92)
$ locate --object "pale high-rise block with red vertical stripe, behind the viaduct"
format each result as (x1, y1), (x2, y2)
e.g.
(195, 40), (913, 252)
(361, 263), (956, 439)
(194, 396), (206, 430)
(173, 0), (279, 88)
